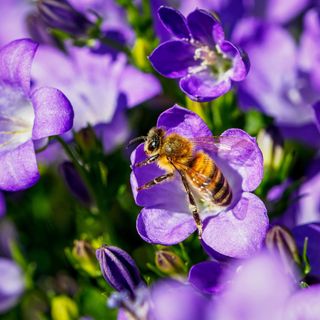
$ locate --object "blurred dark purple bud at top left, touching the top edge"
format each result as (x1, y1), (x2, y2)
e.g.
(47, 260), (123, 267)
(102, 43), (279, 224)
(37, 0), (92, 35)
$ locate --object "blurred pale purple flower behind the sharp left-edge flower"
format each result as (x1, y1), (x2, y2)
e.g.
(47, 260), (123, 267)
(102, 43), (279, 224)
(32, 46), (161, 150)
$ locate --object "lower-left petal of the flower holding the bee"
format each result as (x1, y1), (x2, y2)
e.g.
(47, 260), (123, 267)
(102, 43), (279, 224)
(137, 208), (196, 245)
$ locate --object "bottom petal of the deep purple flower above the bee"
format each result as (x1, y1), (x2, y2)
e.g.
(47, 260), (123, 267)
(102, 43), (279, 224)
(180, 70), (231, 102)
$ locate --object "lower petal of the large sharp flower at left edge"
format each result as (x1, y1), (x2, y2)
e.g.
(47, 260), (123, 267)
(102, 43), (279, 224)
(0, 140), (39, 191)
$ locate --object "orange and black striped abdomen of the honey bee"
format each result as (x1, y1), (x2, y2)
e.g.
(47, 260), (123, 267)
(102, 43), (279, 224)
(187, 151), (232, 206)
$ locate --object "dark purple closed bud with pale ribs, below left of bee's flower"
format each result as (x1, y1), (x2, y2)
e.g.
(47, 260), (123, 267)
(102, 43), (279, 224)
(96, 245), (142, 297)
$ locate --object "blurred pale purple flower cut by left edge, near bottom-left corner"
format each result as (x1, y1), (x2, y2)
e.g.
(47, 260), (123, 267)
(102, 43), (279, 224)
(0, 257), (25, 314)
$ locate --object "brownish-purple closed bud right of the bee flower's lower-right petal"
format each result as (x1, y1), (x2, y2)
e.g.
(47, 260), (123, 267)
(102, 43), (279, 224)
(266, 226), (301, 278)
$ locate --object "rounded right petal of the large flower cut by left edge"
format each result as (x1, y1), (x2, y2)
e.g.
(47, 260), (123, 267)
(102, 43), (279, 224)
(31, 87), (74, 140)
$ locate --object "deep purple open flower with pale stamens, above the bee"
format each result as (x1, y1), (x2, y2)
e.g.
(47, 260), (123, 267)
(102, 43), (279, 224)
(149, 6), (249, 101)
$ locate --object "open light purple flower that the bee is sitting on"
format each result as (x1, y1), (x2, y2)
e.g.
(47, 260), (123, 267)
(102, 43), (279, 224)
(131, 105), (268, 257)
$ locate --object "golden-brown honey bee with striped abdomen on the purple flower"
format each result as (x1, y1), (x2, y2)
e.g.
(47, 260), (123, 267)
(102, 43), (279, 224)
(129, 127), (232, 239)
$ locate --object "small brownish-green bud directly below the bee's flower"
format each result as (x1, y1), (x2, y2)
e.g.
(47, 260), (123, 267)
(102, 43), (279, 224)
(155, 250), (183, 274)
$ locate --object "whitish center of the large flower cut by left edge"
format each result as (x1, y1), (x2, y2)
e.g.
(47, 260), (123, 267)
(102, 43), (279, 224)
(0, 84), (34, 154)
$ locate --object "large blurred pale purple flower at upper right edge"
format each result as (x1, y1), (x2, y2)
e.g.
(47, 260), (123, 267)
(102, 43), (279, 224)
(233, 15), (320, 145)
